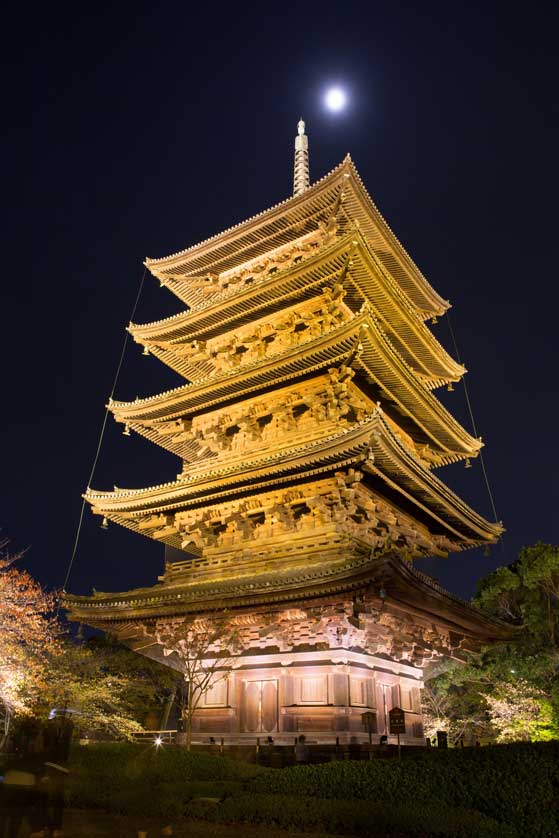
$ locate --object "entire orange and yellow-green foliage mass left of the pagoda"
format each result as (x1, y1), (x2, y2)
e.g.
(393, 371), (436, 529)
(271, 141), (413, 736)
(0, 542), (176, 746)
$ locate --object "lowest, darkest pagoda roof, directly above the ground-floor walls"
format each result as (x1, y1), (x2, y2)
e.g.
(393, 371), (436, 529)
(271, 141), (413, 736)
(63, 556), (517, 642)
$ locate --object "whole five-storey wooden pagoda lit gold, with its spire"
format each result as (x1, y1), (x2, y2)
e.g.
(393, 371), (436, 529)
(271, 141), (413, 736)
(66, 127), (504, 743)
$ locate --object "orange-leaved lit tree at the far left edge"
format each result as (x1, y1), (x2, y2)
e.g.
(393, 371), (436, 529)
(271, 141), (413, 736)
(0, 541), (60, 746)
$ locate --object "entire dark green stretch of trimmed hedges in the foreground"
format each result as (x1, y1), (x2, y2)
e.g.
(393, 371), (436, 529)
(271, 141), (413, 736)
(67, 742), (559, 838)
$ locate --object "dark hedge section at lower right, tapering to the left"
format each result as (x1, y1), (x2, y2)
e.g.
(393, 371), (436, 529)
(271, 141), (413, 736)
(250, 742), (559, 835)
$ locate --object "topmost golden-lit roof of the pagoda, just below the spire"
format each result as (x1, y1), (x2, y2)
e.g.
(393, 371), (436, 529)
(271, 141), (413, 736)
(145, 155), (449, 317)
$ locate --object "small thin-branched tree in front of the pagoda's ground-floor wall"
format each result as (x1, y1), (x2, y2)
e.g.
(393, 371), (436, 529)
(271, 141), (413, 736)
(156, 615), (239, 750)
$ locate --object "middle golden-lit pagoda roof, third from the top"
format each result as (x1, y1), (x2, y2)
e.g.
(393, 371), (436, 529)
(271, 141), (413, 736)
(109, 307), (482, 463)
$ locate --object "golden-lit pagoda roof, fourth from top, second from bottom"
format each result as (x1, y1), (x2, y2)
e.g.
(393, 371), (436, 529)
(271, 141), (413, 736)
(88, 408), (503, 549)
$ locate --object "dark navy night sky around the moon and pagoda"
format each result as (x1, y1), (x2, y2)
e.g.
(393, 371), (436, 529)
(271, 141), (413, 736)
(0, 2), (559, 597)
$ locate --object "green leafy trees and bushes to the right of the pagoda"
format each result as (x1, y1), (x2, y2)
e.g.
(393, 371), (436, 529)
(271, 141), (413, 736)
(424, 542), (559, 742)
